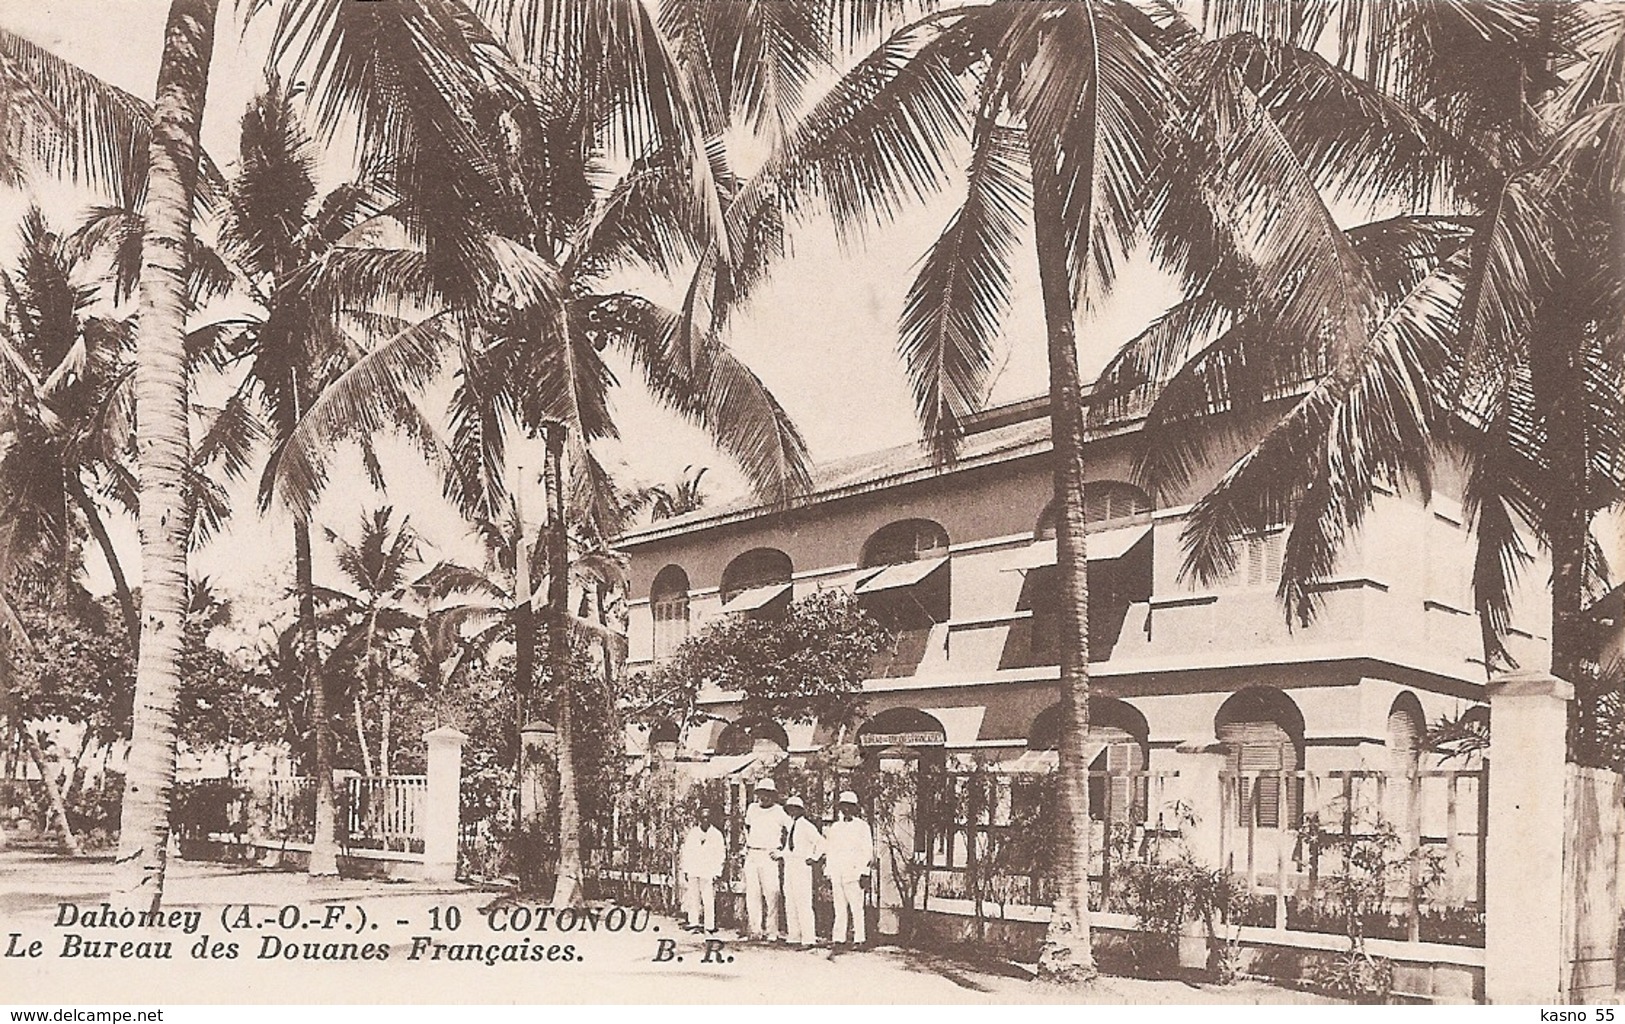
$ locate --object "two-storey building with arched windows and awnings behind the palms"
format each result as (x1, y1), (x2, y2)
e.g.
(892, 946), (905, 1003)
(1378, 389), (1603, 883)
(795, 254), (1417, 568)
(619, 398), (1549, 786)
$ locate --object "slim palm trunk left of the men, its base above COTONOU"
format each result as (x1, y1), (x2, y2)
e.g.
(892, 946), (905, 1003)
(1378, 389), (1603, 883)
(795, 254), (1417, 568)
(544, 423), (582, 907)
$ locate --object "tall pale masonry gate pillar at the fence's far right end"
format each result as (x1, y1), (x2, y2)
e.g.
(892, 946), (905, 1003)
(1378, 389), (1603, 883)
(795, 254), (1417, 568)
(1484, 671), (1575, 1004)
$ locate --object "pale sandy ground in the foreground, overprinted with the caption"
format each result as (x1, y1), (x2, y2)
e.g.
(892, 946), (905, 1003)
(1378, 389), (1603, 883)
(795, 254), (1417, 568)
(0, 850), (1326, 1004)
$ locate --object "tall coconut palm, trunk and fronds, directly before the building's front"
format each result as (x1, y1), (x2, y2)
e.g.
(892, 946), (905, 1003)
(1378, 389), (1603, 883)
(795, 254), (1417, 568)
(705, 3), (1488, 975)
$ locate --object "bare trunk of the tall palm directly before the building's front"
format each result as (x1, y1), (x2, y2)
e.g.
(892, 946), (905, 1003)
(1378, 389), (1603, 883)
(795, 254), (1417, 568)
(1030, 133), (1095, 982)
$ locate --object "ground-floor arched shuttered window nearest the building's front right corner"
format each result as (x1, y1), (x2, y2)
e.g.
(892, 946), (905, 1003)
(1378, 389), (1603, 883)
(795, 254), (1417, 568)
(1214, 686), (1303, 829)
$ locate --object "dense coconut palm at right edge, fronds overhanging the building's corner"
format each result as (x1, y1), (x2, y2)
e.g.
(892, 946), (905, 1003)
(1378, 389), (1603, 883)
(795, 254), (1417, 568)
(1107, 0), (1625, 689)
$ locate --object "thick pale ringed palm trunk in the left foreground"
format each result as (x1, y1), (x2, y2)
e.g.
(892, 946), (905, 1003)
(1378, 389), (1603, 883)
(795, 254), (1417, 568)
(117, 0), (218, 910)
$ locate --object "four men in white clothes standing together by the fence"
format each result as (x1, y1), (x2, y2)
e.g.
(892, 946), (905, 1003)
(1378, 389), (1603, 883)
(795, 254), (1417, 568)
(679, 779), (874, 948)
